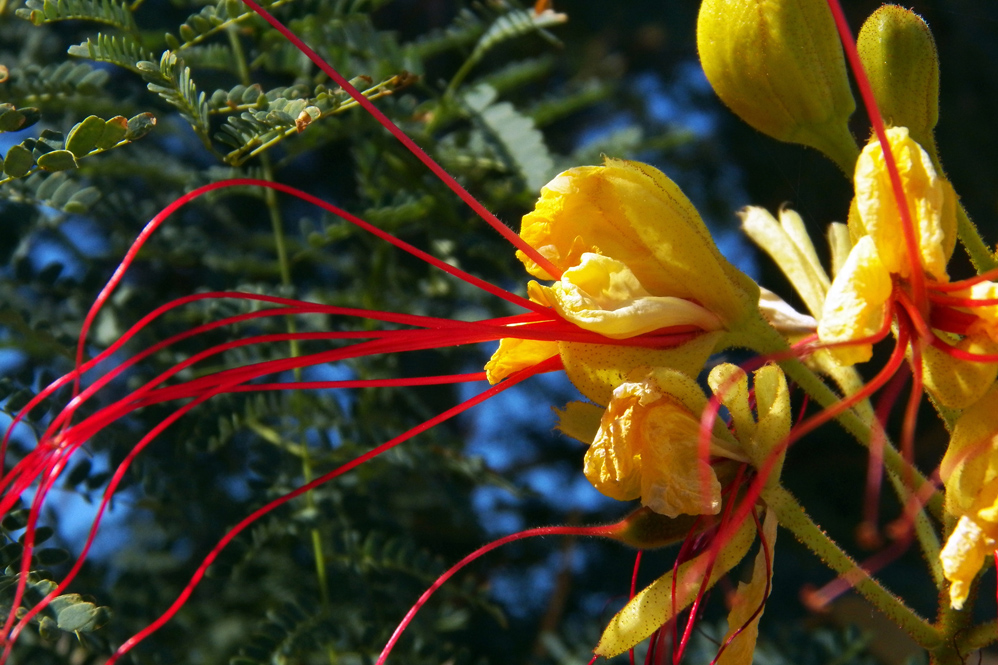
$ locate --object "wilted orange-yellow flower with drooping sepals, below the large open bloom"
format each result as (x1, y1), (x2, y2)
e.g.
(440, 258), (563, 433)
(586, 364), (790, 664)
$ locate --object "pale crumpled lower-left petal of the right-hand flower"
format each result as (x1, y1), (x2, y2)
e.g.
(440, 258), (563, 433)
(818, 236), (893, 365)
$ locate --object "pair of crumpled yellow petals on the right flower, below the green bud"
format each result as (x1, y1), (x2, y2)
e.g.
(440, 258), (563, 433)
(818, 127), (956, 365)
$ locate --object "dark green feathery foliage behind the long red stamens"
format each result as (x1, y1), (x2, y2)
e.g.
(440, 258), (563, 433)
(0, 0), (748, 665)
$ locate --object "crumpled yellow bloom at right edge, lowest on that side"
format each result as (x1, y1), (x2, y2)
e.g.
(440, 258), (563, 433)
(939, 385), (998, 609)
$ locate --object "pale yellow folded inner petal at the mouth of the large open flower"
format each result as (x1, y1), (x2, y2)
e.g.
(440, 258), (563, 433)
(536, 252), (722, 339)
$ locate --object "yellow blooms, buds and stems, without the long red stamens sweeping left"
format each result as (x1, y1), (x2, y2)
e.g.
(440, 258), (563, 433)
(476, 0), (998, 663)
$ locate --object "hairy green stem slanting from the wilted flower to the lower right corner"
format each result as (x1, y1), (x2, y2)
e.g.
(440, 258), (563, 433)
(762, 486), (941, 651)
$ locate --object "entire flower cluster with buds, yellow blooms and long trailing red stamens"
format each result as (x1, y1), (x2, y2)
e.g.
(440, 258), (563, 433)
(0, 0), (998, 665)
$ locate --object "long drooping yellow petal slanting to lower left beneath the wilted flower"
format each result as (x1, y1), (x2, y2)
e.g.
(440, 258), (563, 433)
(596, 520), (755, 658)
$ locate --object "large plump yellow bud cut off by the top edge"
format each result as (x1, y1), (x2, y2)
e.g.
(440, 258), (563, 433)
(697, 0), (858, 172)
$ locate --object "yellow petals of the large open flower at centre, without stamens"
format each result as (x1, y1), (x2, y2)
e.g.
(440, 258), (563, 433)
(486, 159), (760, 405)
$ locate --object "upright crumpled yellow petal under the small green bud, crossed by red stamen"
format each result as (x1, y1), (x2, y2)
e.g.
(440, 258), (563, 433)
(850, 127), (956, 282)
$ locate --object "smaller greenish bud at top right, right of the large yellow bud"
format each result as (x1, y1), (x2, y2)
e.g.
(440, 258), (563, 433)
(856, 5), (939, 158)
